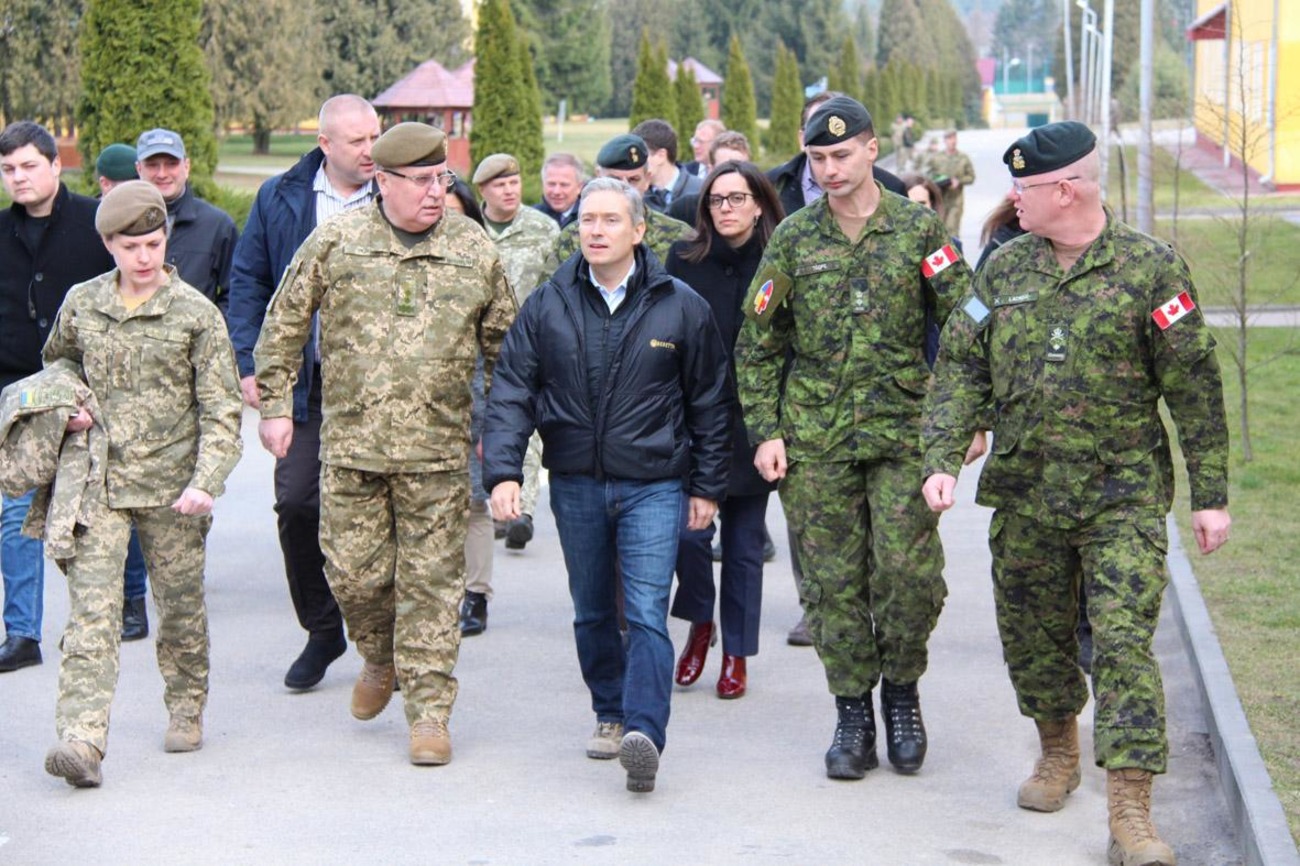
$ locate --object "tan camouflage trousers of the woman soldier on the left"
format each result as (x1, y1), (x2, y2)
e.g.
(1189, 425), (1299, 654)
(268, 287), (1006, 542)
(55, 496), (212, 753)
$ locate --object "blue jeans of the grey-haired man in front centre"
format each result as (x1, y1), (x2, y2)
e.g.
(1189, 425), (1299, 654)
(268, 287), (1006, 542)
(551, 475), (684, 752)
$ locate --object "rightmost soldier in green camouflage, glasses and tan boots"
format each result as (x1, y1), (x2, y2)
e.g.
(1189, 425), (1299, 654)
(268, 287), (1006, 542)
(923, 121), (1230, 866)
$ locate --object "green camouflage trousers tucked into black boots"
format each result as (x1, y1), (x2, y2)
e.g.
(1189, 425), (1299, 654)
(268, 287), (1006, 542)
(780, 455), (948, 696)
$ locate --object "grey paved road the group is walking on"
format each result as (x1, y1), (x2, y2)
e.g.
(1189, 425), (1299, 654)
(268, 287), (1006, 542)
(0, 131), (1240, 866)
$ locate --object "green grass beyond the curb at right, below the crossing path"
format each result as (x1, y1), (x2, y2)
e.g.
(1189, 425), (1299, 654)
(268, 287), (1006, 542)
(1175, 328), (1300, 840)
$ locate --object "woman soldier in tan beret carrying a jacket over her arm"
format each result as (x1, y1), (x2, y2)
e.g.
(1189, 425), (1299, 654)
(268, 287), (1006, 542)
(44, 181), (242, 787)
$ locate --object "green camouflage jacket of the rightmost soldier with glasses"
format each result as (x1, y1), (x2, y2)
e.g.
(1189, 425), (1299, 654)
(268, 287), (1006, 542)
(926, 211), (1227, 527)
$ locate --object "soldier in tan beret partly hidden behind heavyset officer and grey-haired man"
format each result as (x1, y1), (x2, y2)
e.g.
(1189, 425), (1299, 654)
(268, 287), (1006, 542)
(475, 153), (560, 572)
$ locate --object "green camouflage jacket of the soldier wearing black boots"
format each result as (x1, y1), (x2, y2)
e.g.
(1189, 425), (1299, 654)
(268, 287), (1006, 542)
(736, 182), (970, 460)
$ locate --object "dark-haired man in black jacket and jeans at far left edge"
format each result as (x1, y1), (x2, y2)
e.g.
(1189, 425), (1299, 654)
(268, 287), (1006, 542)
(0, 121), (113, 672)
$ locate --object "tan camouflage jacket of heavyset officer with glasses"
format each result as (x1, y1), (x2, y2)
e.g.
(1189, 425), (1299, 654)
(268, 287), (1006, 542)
(254, 202), (516, 472)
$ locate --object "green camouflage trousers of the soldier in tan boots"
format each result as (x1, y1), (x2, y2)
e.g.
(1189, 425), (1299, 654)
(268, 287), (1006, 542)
(989, 510), (1169, 772)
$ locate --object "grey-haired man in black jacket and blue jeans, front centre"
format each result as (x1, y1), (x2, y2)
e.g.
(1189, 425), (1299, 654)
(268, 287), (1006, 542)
(484, 178), (733, 792)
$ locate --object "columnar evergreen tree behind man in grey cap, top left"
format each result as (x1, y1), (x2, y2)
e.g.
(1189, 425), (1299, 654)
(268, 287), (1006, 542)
(77, 0), (217, 195)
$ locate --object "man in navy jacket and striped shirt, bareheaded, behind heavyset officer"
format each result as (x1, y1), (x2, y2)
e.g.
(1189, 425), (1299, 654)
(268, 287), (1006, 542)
(229, 95), (380, 689)
